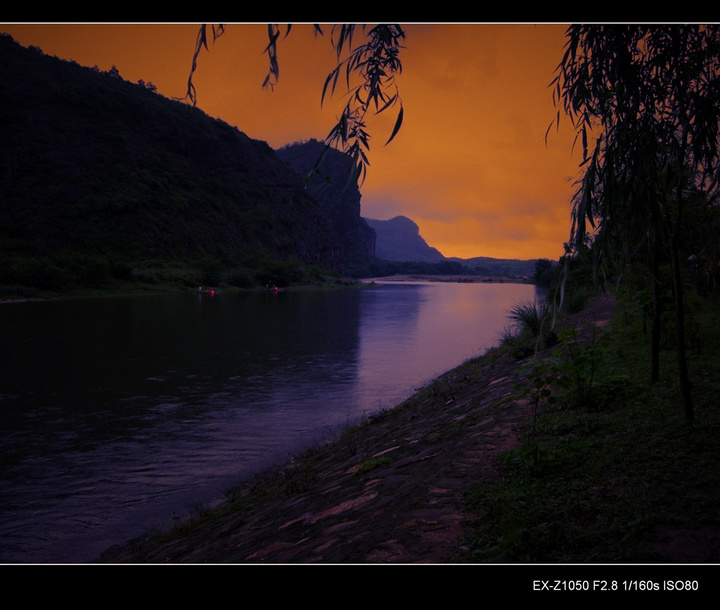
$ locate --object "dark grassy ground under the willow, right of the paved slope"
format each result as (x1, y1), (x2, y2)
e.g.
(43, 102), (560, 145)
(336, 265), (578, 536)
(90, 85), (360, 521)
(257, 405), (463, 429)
(464, 280), (720, 563)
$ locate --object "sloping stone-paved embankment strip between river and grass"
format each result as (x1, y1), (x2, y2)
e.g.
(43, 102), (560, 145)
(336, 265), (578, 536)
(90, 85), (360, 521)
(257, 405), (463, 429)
(100, 290), (613, 563)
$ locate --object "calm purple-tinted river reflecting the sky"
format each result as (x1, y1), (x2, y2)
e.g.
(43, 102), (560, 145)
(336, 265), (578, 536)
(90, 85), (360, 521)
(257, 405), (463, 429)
(0, 283), (535, 563)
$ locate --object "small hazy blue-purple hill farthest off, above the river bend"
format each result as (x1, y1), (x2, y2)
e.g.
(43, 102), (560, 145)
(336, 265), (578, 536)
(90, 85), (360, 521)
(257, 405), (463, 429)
(367, 216), (445, 263)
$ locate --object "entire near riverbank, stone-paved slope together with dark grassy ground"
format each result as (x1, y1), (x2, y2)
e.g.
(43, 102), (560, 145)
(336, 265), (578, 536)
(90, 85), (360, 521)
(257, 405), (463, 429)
(99, 284), (720, 564)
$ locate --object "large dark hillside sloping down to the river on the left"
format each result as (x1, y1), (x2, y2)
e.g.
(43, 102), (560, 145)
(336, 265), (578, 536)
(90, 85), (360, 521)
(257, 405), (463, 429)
(0, 35), (343, 290)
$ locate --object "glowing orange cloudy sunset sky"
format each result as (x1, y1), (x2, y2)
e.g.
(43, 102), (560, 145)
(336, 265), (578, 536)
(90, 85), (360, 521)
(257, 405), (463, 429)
(0, 23), (579, 259)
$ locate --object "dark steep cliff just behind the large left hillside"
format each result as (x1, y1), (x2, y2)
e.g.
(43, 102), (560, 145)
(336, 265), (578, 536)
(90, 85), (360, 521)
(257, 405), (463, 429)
(277, 140), (375, 277)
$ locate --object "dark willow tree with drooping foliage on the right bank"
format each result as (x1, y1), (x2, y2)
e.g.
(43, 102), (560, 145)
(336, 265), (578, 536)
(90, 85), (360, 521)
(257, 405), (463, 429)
(553, 25), (720, 419)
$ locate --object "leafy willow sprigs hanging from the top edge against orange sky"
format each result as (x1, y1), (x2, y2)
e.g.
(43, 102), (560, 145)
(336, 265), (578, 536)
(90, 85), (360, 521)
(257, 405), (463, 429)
(186, 24), (405, 182)
